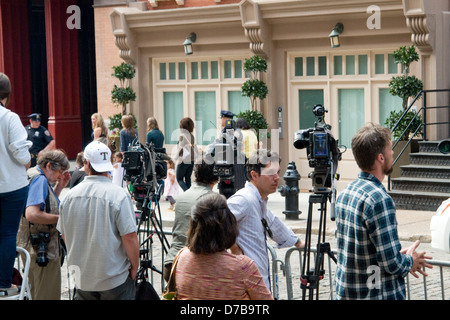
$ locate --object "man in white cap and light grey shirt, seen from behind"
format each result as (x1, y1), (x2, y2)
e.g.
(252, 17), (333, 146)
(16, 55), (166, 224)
(57, 141), (139, 300)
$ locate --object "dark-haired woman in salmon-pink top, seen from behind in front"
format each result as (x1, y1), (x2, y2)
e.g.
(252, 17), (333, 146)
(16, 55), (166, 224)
(175, 192), (273, 300)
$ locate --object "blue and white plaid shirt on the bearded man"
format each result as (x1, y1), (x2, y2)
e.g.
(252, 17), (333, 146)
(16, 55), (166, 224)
(335, 172), (413, 299)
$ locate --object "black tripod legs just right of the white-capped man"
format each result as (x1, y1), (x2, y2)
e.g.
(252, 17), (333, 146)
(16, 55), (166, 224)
(136, 185), (170, 291)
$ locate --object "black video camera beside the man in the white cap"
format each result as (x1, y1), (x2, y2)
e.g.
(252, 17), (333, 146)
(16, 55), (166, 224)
(122, 142), (169, 210)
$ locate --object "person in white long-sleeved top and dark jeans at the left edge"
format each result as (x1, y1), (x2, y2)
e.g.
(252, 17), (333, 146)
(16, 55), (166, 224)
(0, 72), (32, 296)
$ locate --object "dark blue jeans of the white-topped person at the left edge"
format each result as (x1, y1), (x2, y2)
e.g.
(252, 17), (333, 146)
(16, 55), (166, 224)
(0, 185), (28, 288)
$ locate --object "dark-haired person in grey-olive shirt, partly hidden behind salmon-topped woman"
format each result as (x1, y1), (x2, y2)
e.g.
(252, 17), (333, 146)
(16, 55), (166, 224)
(164, 161), (219, 281)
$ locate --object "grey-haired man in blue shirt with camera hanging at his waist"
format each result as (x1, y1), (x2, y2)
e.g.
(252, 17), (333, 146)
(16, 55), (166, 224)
(17, 150), (70, 300)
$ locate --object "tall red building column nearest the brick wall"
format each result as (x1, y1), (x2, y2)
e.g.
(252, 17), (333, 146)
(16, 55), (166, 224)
(45, 0), (82, 159)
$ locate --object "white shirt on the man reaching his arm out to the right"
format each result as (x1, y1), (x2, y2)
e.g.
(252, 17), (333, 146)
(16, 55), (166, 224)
(227, 182), (298, 289)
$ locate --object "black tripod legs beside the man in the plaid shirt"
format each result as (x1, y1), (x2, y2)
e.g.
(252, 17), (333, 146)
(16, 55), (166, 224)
(300, 190), (337, 300)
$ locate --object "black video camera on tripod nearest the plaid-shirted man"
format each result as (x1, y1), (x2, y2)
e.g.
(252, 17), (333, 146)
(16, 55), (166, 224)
(294, 104), (342, 193)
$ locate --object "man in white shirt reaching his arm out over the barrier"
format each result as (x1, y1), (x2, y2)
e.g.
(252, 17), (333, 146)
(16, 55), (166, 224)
(227, 149), (305, 290)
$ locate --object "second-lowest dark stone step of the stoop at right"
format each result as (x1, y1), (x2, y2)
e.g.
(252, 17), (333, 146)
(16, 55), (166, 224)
(391, 177), (450, 194)
